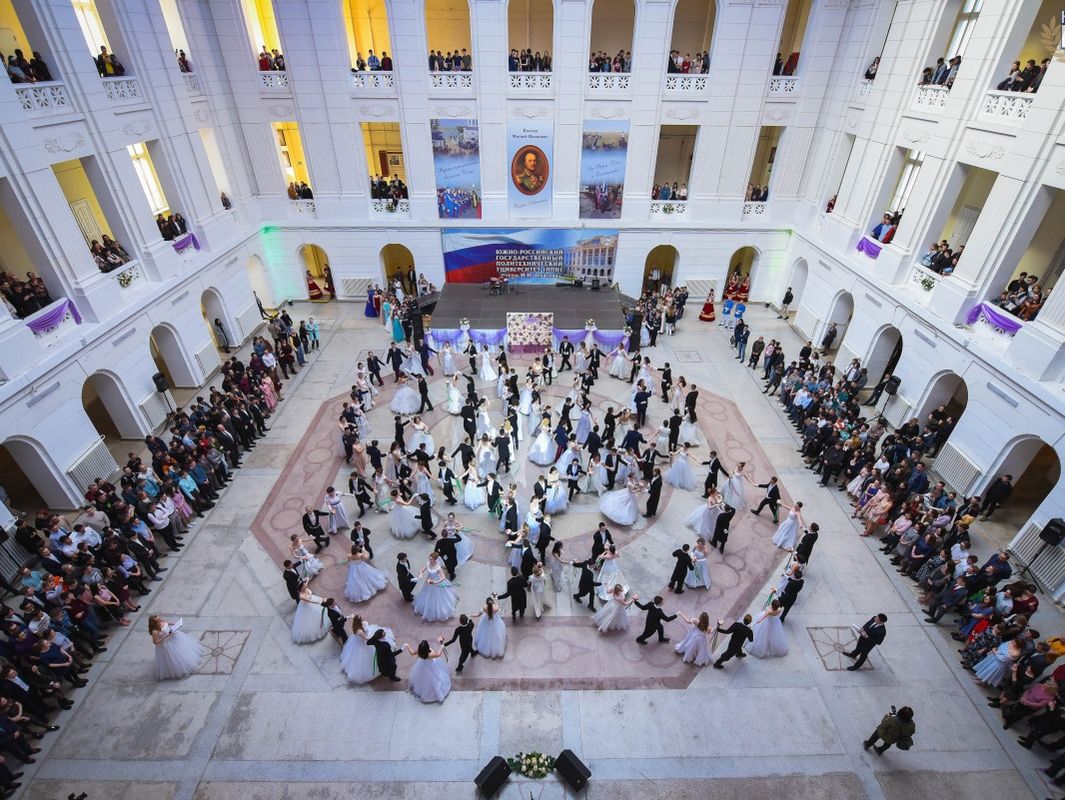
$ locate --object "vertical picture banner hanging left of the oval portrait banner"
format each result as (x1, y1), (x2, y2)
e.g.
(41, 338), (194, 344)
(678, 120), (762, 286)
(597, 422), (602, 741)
(429, 119), (480, 219)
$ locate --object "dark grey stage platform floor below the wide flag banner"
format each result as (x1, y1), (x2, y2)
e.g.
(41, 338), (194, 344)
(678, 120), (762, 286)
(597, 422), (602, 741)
(423, 283), (625, 330)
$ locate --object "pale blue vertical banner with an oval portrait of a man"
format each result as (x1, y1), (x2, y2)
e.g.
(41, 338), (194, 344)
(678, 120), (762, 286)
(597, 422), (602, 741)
(507, 119), (554, 218)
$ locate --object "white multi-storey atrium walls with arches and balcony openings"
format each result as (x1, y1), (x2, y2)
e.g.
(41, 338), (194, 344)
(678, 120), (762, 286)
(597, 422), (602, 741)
(0, 0), (1065, 595)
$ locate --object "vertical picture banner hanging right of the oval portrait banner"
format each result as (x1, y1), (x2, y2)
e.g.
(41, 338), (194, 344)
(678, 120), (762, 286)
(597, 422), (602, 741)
(580, 119), (628, 219)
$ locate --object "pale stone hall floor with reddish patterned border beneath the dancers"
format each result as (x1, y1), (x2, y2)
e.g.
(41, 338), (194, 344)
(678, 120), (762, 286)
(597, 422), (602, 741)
(23, 304), (1061, 800)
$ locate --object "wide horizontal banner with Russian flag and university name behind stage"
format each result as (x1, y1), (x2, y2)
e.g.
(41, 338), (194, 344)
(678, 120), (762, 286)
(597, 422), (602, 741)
(440, 228), (618, 284)
